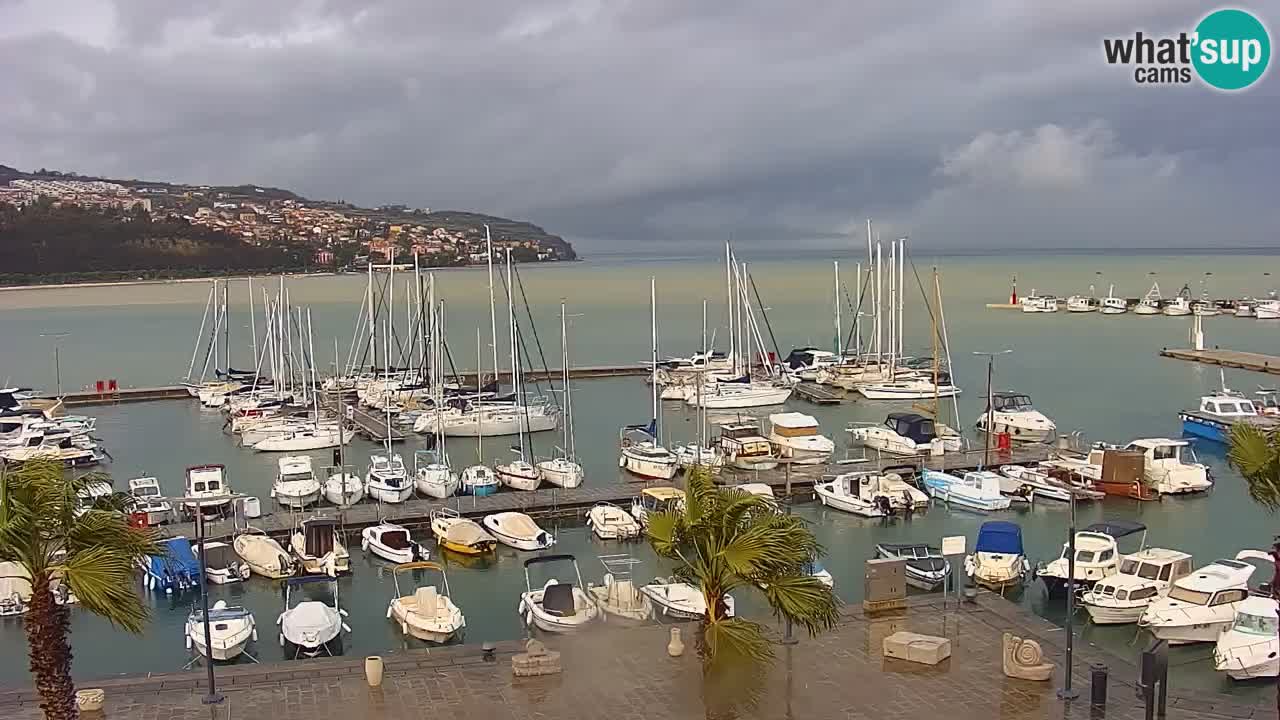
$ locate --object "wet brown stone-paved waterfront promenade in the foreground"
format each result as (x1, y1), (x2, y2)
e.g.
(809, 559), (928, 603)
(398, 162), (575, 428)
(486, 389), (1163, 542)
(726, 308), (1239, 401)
(0, 596), (1276, 720)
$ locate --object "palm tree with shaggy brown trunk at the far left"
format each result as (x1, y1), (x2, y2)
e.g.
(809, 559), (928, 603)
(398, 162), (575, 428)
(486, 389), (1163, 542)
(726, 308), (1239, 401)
(0, 460), (163, 720)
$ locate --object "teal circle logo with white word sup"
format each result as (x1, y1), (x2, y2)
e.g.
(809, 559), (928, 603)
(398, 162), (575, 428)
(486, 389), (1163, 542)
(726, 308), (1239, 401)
(1192, 9), (1271, 90)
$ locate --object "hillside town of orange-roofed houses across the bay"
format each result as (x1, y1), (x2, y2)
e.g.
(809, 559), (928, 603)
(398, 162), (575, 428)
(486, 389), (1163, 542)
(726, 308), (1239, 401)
(0, 177), (576, 268)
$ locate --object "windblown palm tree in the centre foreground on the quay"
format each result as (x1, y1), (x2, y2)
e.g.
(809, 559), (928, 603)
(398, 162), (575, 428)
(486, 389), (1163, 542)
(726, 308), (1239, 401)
(646, 468), (840, 715)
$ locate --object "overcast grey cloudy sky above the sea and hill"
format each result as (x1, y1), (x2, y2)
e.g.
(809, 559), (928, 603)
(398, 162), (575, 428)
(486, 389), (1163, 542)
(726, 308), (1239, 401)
(0, 0), (1280, 250)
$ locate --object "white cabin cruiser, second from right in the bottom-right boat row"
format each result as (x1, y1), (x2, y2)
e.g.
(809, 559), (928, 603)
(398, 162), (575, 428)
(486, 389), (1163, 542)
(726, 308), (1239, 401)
(1138, 551), (1275, 644)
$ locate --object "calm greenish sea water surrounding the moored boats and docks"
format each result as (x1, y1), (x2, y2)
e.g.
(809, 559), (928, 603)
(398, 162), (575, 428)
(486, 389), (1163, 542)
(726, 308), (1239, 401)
(0, 255), (1280, 693)
